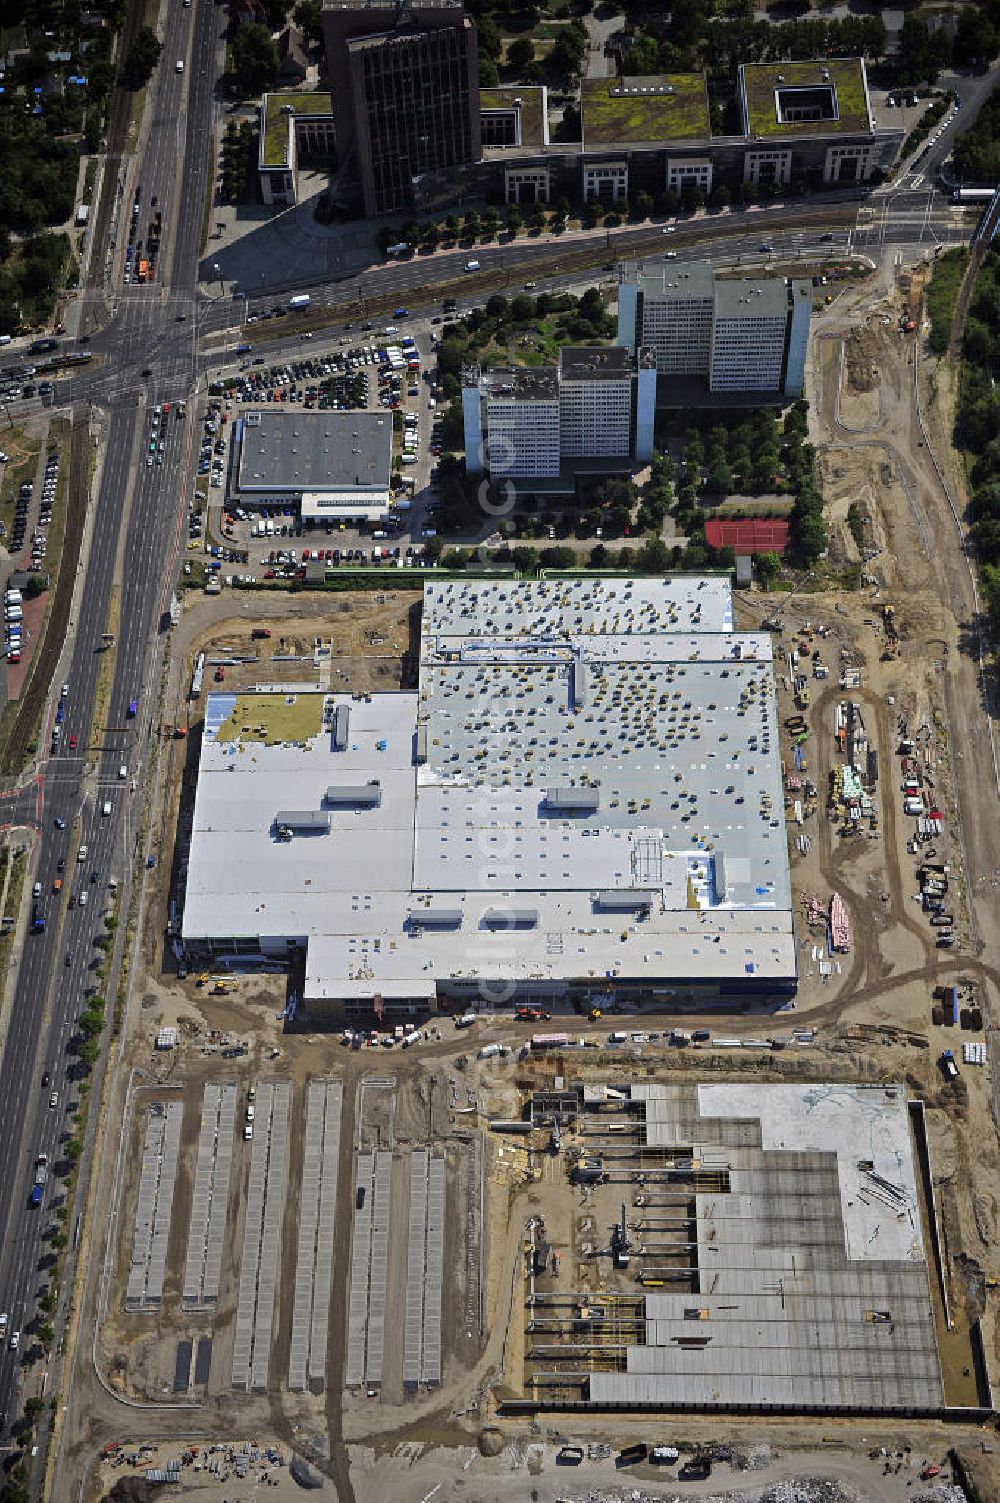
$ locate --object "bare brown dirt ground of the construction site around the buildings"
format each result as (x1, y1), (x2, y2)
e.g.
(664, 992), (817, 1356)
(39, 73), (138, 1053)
(56, 252), (1000, 1503)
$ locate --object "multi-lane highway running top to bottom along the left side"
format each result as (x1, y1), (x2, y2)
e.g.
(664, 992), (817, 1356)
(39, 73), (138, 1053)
(0, 6), (224, 1454)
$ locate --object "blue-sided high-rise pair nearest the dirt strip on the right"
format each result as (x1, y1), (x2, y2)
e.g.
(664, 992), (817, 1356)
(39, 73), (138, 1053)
(618, 263), (812, 398)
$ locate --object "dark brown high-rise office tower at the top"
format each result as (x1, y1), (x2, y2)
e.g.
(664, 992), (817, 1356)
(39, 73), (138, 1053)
(323, 0), (480, 215)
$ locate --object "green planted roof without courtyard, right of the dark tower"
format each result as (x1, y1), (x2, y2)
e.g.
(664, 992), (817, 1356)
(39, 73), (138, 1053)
(580, 74), (711, 147)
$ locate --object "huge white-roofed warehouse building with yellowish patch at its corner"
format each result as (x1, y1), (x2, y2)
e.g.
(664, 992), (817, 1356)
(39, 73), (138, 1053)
(182, 577), (795, 1016)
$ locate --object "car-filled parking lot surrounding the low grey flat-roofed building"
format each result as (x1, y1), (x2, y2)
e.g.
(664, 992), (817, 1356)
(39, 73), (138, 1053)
(195, 326), (441, 582)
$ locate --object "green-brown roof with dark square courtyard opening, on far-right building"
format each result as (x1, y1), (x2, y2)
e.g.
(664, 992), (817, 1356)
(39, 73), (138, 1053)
(740, 57), (872, 138)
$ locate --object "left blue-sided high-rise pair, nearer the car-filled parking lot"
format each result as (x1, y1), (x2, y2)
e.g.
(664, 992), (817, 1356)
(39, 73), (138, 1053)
(462, 346), (656, 479)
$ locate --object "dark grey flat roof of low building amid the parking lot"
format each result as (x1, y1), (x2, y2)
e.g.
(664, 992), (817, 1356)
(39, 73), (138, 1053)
(238, 407), (392, 491)
